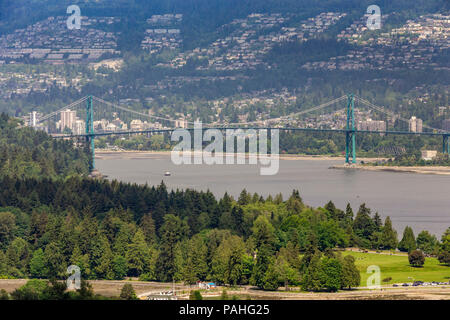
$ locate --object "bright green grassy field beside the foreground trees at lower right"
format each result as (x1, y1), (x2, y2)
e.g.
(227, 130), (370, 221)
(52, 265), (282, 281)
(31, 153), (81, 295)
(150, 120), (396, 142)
(342, 251), (450, 286)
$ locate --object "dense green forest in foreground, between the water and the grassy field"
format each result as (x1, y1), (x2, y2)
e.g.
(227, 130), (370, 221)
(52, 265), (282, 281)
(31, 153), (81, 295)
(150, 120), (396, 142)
(0, 177), (450, 291)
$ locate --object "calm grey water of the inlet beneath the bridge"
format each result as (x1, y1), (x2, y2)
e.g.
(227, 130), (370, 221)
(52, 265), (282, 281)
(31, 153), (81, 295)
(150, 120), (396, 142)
(96, 154), (450, 238)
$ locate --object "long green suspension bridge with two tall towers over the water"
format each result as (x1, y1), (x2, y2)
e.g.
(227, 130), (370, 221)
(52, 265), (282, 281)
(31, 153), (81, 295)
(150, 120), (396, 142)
(36, 94), (450, 169)
